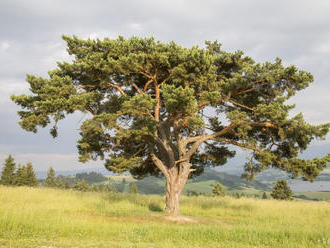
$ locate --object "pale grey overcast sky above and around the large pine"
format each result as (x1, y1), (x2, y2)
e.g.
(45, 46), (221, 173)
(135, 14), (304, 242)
(0, 0), (330, 170)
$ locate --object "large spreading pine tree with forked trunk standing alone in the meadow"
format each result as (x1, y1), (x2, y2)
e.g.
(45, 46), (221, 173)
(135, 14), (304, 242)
(12, 36), (330, 213)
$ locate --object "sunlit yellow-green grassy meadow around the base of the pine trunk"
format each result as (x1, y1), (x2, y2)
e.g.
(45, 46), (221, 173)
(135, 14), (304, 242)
(0, 187), (330, 248)
